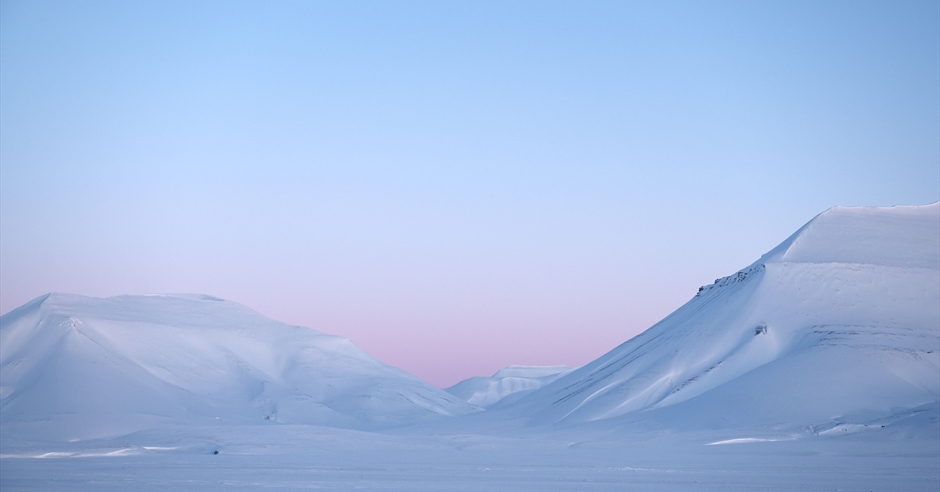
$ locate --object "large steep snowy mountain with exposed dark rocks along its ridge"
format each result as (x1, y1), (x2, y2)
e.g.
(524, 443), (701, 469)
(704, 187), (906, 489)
(509, 203), (940, 428)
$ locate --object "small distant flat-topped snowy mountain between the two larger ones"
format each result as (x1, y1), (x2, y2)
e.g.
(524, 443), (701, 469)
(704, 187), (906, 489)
(444, 366), (571, 408)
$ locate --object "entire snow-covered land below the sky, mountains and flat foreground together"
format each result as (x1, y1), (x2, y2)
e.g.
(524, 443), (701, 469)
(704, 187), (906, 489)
(0, 204), (940, 491)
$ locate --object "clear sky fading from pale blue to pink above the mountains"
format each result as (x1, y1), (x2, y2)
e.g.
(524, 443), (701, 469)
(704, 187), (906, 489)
(0, 0), (940, 387)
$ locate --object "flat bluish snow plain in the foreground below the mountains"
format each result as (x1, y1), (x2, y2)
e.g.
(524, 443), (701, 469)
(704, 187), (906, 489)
(0, 418), (940, 492)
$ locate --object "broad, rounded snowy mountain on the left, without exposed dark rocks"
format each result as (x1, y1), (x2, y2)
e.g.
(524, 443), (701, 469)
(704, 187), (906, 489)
(0, 294), (474, 439)
